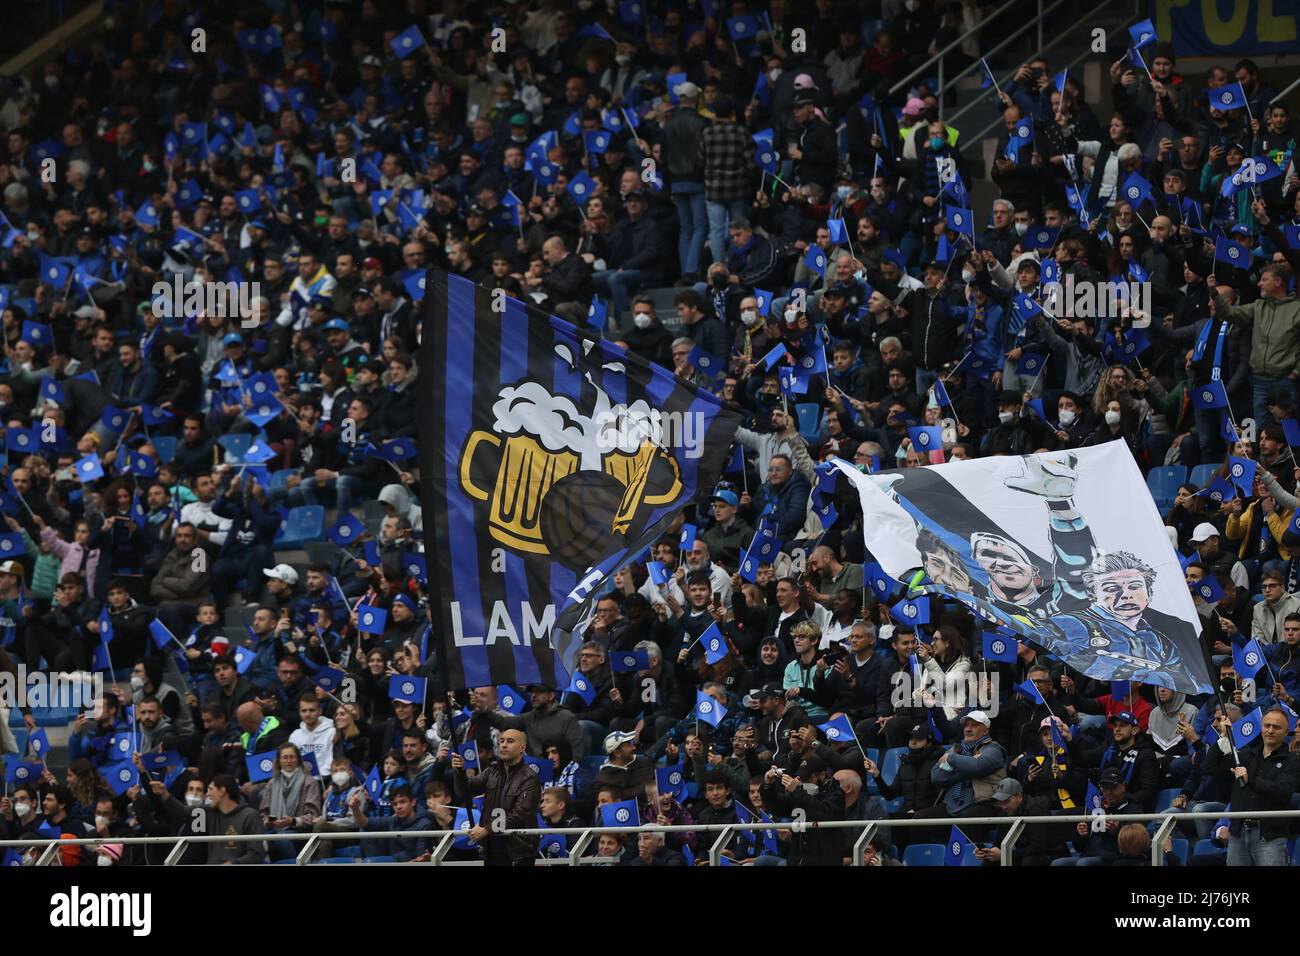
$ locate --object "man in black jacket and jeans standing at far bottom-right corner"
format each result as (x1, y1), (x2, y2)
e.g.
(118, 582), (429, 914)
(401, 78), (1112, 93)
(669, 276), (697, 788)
(1205, 708), (1300, 866)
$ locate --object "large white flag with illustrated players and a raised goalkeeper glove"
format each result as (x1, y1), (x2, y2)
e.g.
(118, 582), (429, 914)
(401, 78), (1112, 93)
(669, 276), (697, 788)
(836, 441), (1213, 693)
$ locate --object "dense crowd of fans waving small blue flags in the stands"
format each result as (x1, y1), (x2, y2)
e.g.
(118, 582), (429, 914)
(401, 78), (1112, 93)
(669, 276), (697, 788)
(0, 0), (1300, 865)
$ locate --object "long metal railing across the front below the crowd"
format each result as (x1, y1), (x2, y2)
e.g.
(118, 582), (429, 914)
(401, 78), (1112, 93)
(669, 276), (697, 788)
(0, 810), (1300, 866)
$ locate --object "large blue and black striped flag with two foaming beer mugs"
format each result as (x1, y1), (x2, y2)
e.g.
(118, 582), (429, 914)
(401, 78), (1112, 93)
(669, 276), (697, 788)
(419, 271), (741, 688)
